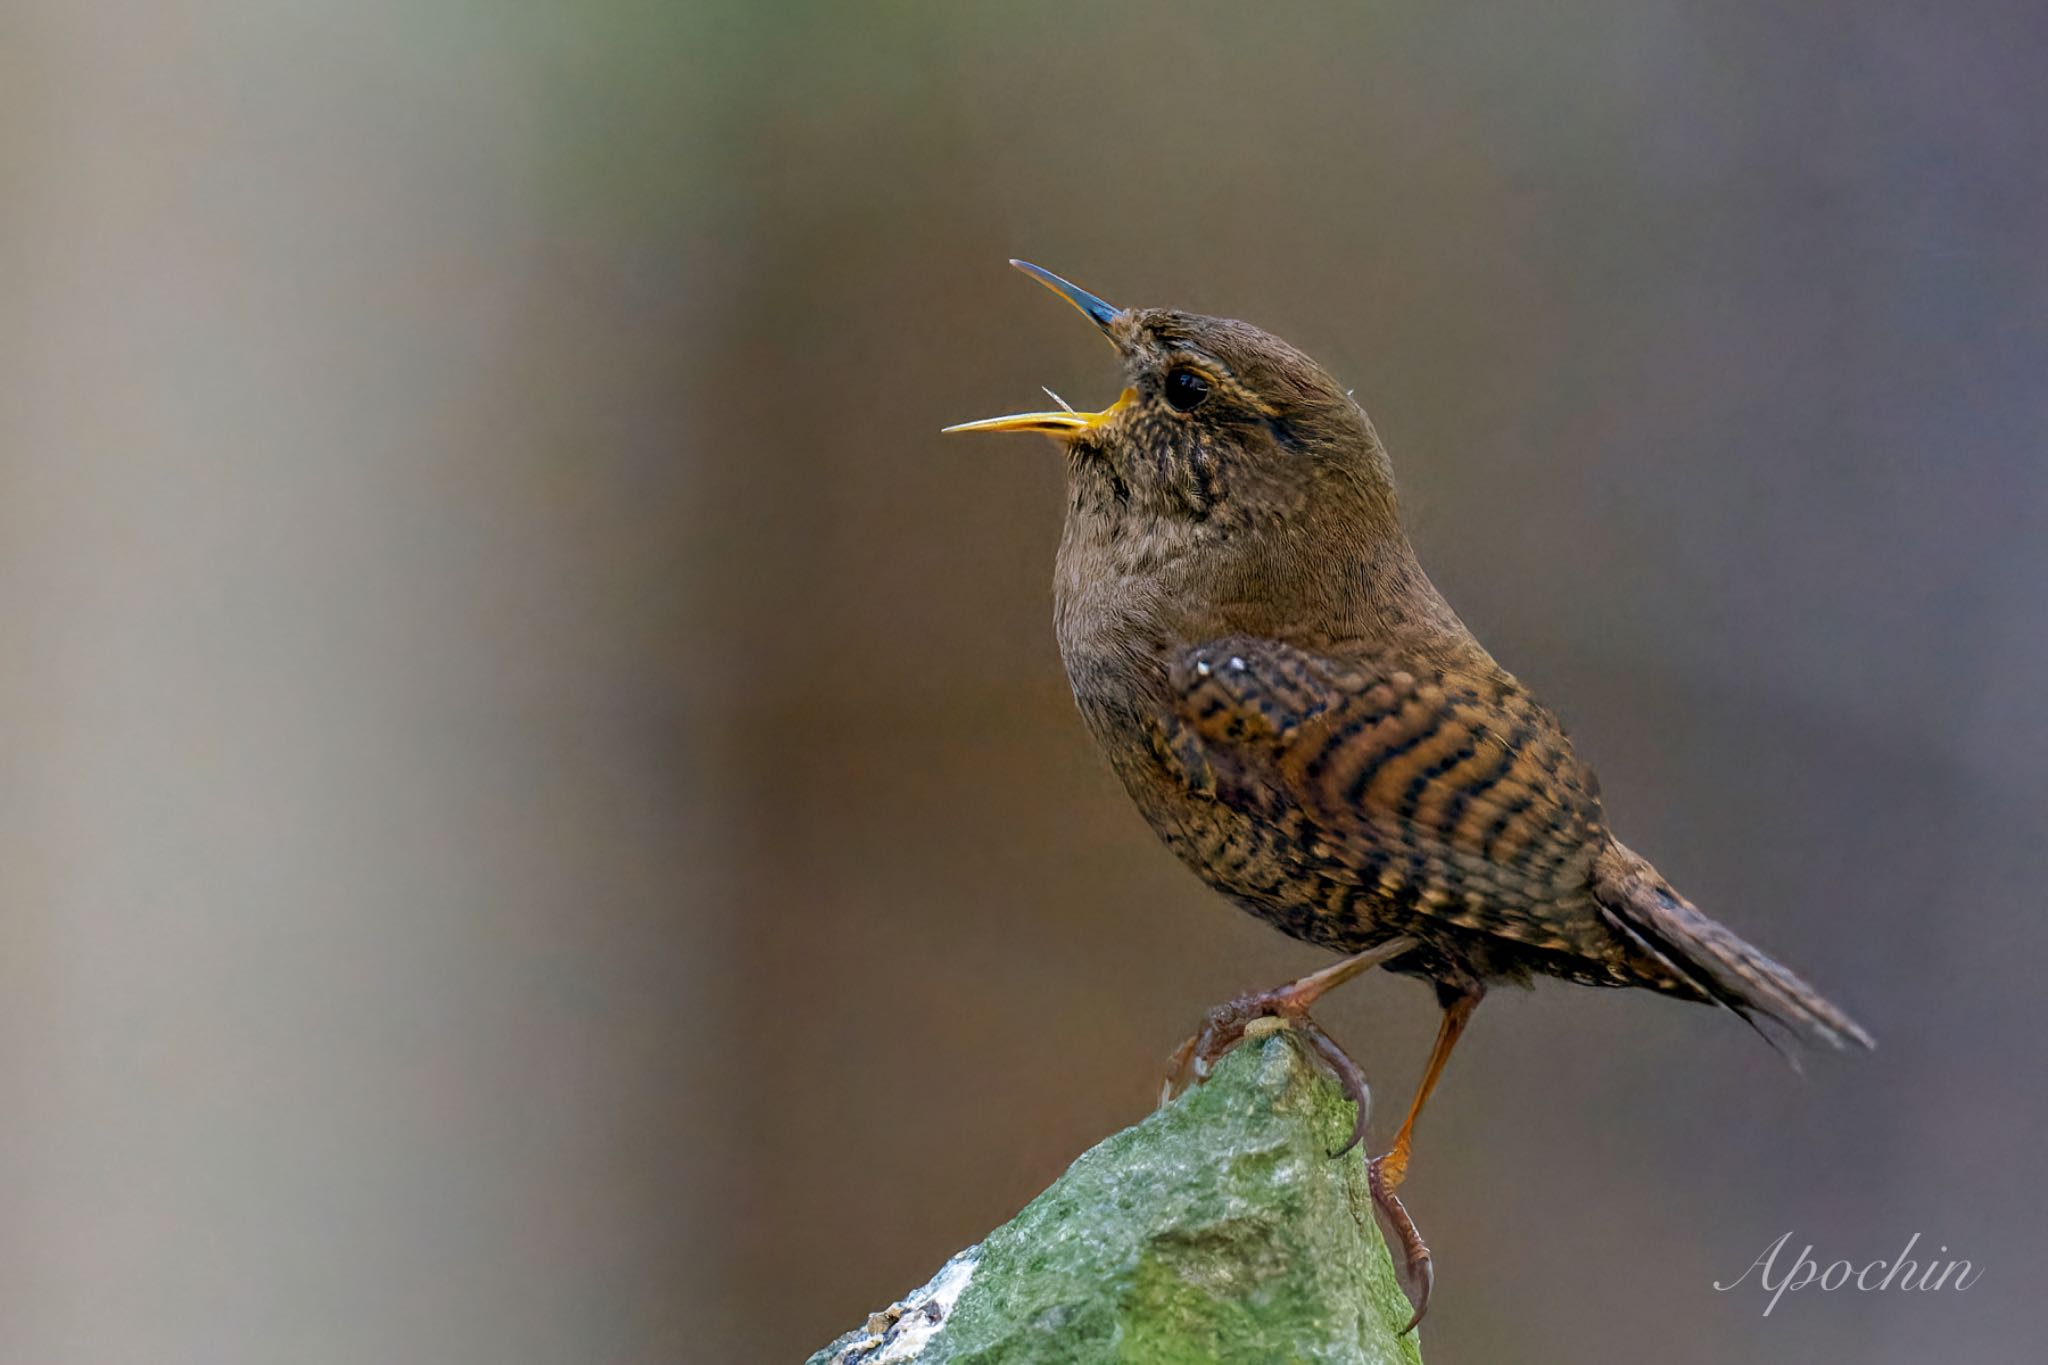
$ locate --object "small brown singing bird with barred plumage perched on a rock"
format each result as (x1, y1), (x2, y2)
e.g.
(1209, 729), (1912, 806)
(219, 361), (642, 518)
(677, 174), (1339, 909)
(944, 260), (1874, 1330)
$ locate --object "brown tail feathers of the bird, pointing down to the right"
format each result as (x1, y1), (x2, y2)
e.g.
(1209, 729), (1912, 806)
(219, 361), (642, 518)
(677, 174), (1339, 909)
(1595, 845), (1878, 1048)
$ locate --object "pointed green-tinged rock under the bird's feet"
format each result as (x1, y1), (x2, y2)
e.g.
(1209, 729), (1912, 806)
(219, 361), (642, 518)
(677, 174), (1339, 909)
(809, 1029), (1421, 1365)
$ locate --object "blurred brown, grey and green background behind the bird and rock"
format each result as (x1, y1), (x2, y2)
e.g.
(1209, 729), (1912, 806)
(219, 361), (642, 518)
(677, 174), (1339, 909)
(0, 0), (2048, 1365)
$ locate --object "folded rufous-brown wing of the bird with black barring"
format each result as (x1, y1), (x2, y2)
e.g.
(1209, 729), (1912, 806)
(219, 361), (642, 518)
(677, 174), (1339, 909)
(1169, 636), (1614, 960)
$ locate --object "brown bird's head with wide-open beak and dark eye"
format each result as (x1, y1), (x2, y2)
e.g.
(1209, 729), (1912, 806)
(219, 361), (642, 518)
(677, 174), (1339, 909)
(946, 260), (1395, 532)
